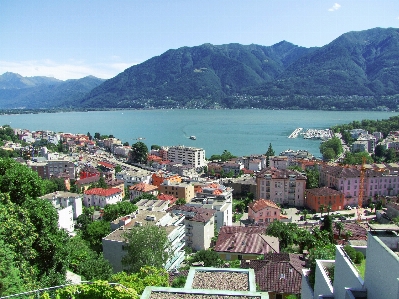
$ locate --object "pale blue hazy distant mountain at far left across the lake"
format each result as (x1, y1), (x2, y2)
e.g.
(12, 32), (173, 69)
(0, 73), (105, 109)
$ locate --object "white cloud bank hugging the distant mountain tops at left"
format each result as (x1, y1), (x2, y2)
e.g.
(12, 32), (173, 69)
(0, 59), (136, 80)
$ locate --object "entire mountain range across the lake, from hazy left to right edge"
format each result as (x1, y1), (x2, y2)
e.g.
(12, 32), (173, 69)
(0, 28), (399, 110)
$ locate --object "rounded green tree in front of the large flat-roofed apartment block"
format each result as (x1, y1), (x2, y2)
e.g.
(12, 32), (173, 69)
(122, 224), (171, 273)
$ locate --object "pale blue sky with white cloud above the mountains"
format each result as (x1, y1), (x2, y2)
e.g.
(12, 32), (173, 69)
(0, 0), (399, 80)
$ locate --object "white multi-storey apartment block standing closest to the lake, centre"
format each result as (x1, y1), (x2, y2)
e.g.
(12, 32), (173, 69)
(168, 145), (206, 168)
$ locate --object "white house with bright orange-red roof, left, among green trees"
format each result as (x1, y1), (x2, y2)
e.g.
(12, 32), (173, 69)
(83, 188), (122, 208)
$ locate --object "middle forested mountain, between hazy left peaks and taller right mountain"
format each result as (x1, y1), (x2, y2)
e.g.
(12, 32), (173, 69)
(81, 42), (313, 108)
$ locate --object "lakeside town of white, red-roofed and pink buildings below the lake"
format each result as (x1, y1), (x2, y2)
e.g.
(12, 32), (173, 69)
(0, 126), (399, 299)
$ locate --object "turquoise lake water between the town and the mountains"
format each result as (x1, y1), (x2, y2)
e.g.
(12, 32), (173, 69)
(0, 109), (397, 157)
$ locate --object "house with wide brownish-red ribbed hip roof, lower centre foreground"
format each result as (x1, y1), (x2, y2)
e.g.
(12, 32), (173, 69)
(215, 226), (280, 261)
